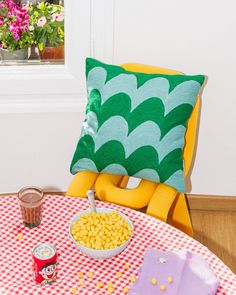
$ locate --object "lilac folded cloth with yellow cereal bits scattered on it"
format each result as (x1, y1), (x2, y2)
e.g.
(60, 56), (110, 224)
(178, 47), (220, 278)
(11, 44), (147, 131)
(128, 249), (219, 295)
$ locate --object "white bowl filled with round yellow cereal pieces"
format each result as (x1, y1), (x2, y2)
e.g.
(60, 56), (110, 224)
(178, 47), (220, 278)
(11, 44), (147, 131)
(69, 208), (133, 259)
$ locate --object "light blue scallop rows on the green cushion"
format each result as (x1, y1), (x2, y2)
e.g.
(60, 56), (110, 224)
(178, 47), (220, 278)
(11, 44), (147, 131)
(72, 67), (201, 192)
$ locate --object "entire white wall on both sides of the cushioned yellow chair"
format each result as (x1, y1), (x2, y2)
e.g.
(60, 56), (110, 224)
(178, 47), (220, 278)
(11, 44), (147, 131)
(0, 0), (236, 195)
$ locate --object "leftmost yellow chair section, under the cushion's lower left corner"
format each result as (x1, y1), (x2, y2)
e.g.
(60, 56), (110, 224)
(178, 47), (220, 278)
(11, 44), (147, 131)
(66, 171), (99, 198)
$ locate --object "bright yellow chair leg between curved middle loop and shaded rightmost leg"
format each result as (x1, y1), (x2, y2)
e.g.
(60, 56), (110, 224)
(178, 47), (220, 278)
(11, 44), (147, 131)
(146, 183), (177, 222)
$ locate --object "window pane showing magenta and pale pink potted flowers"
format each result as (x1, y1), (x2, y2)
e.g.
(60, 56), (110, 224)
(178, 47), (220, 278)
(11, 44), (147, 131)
(0, 0), (65, 66)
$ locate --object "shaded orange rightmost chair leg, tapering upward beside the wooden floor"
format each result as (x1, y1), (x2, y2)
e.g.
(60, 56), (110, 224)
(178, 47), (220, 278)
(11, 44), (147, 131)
(169, 194), (193, 237)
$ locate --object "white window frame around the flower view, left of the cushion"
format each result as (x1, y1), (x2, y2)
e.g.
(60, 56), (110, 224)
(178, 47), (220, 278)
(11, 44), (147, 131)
(0, 0), (114, 113)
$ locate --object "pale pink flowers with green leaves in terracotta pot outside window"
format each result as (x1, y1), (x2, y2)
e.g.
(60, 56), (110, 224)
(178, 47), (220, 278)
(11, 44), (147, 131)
(26, 2), (64, 59)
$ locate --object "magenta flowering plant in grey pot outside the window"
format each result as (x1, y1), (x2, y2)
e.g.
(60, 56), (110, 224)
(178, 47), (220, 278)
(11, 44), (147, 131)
(0, 0), (33, 60)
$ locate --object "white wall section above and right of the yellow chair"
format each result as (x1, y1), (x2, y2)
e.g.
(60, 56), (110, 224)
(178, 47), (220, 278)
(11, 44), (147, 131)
(114, 0), (236, 195)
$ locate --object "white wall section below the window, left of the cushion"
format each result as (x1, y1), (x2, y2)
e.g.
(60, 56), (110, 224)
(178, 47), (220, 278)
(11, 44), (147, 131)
(0, 113), (82, 193)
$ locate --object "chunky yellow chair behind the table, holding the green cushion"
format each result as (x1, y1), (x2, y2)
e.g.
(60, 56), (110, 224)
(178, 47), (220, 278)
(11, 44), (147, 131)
(67, 64), (200, 236)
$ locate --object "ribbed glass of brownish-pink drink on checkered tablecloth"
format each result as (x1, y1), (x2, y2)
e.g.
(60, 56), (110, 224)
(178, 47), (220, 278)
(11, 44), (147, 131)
(17, 186), (43, 228)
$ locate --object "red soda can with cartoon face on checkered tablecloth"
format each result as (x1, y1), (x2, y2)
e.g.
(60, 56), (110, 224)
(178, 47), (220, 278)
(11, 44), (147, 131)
(32, 243), (57, 285)
